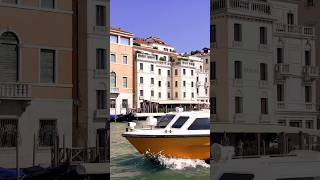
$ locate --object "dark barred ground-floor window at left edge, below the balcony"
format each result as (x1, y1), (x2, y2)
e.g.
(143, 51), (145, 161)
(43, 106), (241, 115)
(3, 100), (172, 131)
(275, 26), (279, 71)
(0, 119), (18, 147)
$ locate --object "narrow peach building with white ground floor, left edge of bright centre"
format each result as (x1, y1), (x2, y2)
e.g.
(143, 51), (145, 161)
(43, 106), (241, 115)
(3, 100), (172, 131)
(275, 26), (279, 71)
(110, 28), (133, 115)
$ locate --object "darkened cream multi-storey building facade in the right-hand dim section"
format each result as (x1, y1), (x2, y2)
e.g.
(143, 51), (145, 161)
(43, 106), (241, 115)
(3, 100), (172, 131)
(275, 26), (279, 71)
(210, 0), (318, 129)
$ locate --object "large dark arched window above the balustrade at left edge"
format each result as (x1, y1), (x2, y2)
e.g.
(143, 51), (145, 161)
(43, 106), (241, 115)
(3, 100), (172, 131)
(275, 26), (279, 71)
(0, 32), (19, 82)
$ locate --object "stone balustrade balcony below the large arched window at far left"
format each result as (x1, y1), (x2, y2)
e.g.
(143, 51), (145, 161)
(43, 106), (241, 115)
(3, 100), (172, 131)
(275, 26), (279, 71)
(0, 82), (31, 99)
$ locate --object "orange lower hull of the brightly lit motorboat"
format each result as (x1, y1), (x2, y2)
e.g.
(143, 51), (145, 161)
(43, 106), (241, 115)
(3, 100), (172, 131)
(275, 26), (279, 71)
(126, 136), (210, 160)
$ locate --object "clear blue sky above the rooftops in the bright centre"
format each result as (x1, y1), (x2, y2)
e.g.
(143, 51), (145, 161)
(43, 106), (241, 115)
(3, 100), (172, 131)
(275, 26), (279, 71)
(110, 0), (210, 52)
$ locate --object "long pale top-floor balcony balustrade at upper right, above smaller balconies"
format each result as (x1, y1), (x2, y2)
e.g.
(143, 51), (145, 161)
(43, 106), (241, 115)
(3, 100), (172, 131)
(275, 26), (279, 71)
(273, 23), (315, 36)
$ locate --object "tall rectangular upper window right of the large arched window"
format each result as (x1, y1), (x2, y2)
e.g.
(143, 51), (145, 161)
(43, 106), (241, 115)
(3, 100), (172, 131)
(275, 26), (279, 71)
(40, 49), (55, 83)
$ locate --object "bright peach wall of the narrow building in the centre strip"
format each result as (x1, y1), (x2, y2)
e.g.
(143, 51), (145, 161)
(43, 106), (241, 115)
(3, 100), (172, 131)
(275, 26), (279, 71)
(110, 43), (133, 93)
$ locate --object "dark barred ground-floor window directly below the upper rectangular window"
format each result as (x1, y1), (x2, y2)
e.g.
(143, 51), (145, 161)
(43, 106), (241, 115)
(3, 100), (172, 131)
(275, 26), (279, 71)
(39, 120), (58, 147)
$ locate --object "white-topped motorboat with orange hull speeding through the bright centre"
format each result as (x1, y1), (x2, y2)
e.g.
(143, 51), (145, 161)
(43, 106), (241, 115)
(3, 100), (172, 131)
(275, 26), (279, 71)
(122, 110), (210, 160)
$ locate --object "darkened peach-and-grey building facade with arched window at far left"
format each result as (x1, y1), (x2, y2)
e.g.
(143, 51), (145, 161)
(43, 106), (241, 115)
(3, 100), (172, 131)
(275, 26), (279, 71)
(0, 0), (73, 168)
